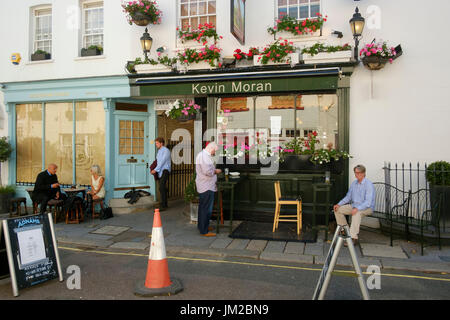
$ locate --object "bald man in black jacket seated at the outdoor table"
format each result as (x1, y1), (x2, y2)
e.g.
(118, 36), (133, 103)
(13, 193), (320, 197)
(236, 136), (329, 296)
(33, 163), (62, 213)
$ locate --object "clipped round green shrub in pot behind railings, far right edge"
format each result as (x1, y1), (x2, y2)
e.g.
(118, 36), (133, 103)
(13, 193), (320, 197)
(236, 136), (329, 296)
(425, 161), (450, 218)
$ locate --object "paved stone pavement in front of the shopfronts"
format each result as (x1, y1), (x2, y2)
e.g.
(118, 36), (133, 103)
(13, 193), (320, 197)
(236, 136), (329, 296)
(33, 200), (450, 273)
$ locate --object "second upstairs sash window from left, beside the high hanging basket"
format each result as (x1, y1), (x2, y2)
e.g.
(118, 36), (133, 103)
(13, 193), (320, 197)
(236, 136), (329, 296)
(81, 1), (103, 49)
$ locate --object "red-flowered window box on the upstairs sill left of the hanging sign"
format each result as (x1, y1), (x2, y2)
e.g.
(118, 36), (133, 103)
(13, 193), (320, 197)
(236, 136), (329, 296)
(177, 23), (223, 47)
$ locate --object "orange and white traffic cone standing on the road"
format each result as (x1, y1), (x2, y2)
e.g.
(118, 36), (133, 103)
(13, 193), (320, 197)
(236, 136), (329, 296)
(135, 209), (183, 297)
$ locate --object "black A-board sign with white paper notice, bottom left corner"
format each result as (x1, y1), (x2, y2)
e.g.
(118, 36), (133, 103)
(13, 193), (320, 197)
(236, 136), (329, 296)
(2, 213), (63, 296)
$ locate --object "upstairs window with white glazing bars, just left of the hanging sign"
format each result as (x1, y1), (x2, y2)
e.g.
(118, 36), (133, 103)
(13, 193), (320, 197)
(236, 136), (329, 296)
(180, 0), (216, 30)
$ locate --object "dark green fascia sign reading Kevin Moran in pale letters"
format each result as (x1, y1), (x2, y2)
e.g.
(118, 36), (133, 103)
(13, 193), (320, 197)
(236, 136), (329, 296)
(139, 75), (337, 97)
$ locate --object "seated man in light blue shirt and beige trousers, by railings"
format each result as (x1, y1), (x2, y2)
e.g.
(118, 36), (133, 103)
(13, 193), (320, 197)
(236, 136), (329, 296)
(333, 164), (375, 244)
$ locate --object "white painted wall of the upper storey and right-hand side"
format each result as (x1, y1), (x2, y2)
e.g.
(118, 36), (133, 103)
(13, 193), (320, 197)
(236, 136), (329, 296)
(0, 0), (450, 186)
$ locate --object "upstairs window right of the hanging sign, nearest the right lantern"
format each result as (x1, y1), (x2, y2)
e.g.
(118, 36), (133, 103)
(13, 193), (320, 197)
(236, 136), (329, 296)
(277, 0), (320, 20)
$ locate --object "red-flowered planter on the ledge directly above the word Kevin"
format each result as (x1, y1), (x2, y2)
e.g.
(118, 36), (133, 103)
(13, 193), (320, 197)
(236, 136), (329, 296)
(177, 44), (222, 70)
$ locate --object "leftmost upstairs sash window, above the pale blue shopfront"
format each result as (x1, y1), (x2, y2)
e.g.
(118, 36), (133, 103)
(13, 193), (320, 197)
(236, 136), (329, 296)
(33, 7), (52, 53)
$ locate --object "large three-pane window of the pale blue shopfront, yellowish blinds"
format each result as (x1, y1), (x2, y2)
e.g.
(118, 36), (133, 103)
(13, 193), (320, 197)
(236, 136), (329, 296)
(16, 101), (105, 184)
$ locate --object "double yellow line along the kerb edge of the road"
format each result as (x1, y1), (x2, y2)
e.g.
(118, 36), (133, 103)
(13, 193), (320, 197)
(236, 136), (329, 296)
(58, 247), (450, 282)
